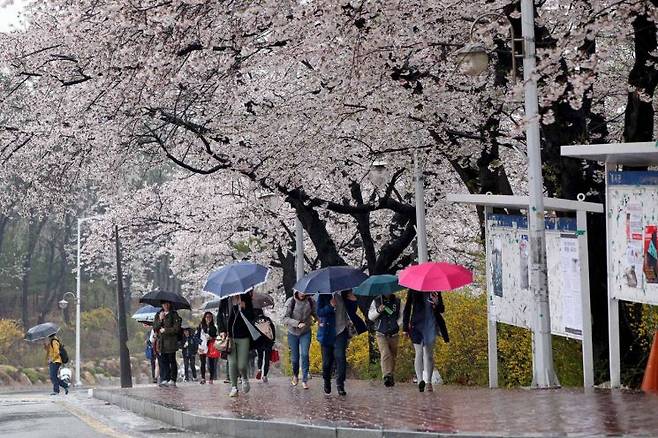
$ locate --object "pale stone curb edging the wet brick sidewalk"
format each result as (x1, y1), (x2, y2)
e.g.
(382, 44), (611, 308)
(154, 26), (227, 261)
(91, 389), (550, 438)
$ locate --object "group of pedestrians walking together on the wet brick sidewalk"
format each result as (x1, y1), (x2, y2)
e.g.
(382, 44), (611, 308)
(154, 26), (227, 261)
(149, 290), (449, 397)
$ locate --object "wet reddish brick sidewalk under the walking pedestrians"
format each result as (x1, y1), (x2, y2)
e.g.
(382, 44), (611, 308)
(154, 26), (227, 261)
(95, 378), (658, 436)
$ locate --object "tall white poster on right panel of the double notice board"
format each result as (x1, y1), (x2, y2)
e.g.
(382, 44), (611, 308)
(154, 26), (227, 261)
(560, 234), (583, 336)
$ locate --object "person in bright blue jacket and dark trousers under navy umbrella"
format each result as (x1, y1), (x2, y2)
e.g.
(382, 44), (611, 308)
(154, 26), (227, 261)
(317, 290), (368, 396)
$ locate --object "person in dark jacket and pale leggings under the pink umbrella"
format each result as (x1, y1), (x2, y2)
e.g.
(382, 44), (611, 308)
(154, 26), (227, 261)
(402, 289), (450, 392)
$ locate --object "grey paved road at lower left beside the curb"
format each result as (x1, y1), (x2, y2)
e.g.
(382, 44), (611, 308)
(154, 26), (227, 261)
(0, 391), (213, 438)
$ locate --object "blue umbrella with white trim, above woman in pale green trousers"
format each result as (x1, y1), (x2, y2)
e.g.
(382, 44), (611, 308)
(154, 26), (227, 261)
(203, 262), (270, 298)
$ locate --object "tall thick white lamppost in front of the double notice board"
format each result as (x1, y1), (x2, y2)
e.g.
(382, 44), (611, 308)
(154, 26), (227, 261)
(521, 0), (559, 388)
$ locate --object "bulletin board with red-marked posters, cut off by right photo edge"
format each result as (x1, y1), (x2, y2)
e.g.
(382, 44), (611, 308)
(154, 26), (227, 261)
(606, 171), (658, 305)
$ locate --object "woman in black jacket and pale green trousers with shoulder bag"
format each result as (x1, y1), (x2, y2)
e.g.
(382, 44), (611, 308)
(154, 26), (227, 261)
(217, 291), (259, 397)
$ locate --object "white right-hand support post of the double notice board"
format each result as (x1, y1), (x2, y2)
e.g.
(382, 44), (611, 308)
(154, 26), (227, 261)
(576, 210), (594, 388)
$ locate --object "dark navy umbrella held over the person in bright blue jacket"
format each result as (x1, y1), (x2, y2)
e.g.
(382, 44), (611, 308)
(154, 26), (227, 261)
(294, 266), (368, 294)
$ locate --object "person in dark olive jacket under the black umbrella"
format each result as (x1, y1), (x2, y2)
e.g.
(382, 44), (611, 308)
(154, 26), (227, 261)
(153, 301), (183, 387)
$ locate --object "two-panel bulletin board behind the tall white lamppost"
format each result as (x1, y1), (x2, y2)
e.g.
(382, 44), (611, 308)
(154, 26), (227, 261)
(486, 214), (587, 340)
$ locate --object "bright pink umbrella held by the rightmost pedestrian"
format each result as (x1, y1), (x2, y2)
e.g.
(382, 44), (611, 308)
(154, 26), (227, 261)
(398, 262), (473, 292)
